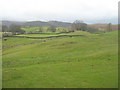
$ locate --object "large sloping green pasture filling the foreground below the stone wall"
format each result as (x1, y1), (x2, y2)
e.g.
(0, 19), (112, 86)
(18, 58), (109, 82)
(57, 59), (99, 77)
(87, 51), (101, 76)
(3, 31), (118, 88)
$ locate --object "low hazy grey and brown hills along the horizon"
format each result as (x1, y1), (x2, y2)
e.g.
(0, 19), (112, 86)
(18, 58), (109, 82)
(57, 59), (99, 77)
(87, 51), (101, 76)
(2, 20), (118, 30)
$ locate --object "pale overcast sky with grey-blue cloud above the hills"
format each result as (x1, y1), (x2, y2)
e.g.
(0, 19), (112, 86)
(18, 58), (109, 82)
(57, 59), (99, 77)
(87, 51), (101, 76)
(0, 0), (119, 23)
